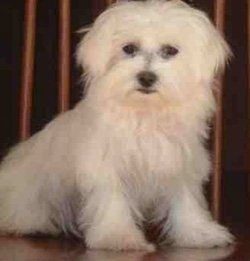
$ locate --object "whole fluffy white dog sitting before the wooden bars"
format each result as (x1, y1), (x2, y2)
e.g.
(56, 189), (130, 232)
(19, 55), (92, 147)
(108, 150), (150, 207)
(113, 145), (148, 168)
(0, 0), (233, 251)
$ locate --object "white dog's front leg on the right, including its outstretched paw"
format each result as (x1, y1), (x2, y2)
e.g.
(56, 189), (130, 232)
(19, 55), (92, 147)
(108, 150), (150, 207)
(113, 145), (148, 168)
(160, 181), (233, 248)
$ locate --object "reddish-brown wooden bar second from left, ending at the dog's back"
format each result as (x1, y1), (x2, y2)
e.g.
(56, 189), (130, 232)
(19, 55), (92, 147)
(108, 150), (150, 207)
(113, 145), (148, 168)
(58, 0), (71, 112)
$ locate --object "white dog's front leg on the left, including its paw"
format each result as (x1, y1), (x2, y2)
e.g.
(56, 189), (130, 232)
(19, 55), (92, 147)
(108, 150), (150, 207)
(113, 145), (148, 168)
(79, 177), (154, 251)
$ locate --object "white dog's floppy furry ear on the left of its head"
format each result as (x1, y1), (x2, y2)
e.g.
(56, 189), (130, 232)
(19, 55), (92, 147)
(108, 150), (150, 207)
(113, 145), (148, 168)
(76, 8), (114, 78)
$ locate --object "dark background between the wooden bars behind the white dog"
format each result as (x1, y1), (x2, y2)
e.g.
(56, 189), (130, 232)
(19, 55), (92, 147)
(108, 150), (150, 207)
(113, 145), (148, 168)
(0, 0), (248, 223)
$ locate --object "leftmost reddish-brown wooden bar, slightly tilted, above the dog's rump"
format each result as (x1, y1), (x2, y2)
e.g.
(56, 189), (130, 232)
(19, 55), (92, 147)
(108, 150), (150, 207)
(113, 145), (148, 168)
(19, 0), (37, 140)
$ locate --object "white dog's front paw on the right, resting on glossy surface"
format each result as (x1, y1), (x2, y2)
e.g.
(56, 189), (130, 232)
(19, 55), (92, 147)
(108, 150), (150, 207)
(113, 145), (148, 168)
(168, 222), (234, 248)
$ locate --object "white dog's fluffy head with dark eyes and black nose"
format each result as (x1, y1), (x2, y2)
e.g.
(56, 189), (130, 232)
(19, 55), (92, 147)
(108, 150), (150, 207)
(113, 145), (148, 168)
(77, 0), (230, 108)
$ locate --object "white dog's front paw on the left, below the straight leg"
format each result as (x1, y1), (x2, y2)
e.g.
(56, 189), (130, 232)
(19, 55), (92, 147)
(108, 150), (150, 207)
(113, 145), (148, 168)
(86, 226), (155, 252)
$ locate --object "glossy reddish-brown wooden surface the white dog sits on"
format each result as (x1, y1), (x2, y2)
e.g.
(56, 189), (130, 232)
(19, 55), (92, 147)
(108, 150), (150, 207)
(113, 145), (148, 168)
(0, 225), (250, 261)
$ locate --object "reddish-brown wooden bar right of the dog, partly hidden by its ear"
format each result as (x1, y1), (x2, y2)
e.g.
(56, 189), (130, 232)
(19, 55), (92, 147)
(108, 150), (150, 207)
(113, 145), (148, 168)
(212, 0), (226, 220)
